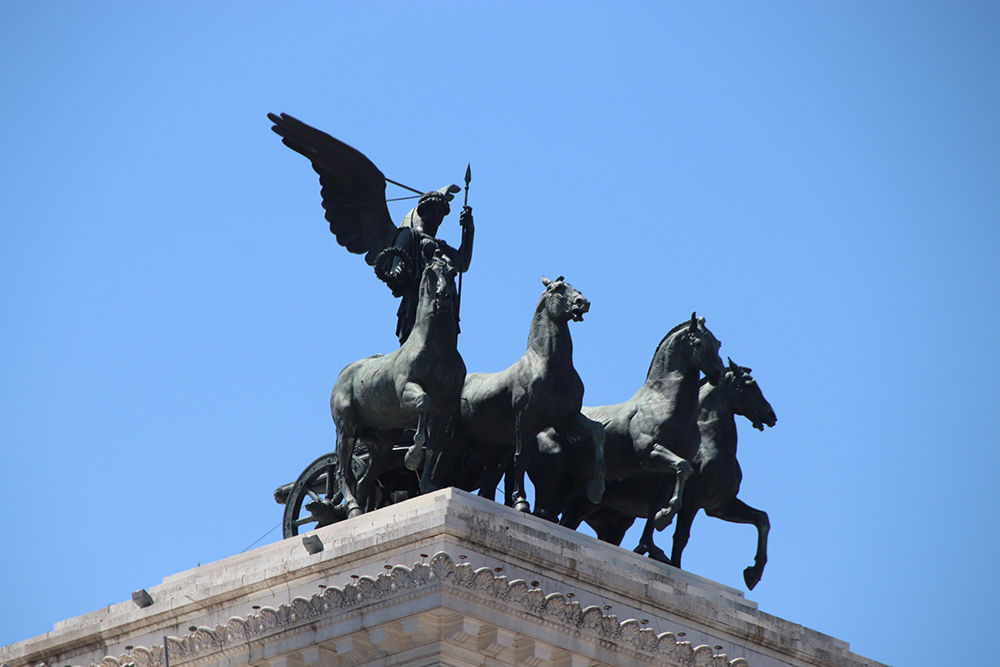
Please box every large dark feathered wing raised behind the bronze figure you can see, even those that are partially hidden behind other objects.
[267,113,397,264]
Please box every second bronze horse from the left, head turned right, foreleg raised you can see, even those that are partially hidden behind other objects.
[461,276,604,512]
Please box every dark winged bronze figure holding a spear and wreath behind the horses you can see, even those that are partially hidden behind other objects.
[267,113,475,345]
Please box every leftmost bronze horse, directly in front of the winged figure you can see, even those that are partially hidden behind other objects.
[330,251,465,517]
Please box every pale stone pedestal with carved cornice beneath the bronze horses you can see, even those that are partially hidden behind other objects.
[0,489,878,667]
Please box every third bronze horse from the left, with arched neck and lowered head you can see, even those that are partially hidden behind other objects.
[552,313,725,562]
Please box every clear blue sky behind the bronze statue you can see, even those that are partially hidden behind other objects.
[0,0,1000,665]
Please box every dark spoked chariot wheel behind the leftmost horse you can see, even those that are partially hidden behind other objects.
[279,453,360,537]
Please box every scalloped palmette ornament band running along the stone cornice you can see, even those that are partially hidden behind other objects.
[82,552,747,667]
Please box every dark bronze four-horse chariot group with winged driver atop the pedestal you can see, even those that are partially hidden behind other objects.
[268,114,776,588]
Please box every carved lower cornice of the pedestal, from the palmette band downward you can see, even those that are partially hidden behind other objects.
[95,552,747,667]
